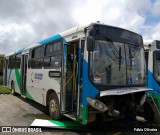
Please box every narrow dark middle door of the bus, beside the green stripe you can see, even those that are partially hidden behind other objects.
[21,54,28,95]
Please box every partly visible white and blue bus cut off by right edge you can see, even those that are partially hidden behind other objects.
[144,40,160,124]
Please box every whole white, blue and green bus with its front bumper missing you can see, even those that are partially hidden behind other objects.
[4,23,155,125]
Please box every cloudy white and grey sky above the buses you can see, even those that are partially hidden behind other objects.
[0,0,160,54]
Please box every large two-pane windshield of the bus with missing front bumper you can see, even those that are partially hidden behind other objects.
[89,40,146,86]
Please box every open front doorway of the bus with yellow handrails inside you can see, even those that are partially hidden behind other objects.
[61,41,79,116]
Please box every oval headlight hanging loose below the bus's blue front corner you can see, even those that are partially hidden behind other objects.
[87,97,108,112]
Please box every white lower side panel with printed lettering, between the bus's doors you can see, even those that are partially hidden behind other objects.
[27,69,61,106]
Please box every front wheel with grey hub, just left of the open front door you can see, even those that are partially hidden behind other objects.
[48,93,61,120]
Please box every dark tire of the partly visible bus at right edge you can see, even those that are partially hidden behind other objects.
[143,99,160,125]
